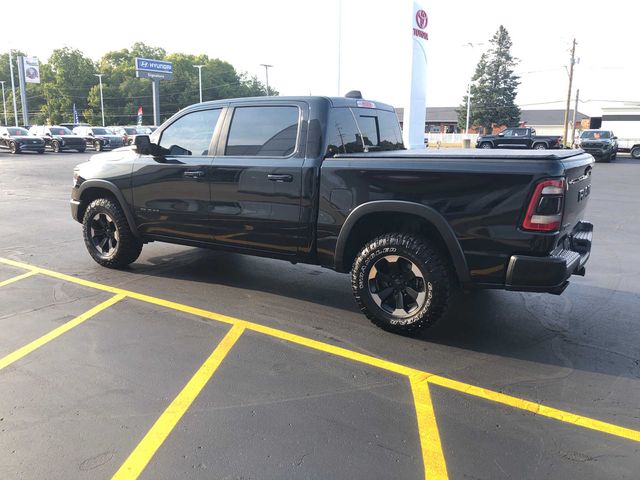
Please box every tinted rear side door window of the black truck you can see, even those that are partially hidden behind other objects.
[225,106,300,157]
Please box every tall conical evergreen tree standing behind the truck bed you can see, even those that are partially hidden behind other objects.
[458,25,520,132]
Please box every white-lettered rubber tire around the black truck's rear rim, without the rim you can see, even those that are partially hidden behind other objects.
[351,233,454,335]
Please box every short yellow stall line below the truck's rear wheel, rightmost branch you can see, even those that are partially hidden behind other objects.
[409,377,449,480]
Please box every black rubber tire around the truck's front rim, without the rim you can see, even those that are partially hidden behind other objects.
[82,198,142,268]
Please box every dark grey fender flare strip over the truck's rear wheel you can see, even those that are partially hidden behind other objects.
[334,200,471,283]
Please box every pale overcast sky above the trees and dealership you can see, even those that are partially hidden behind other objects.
[0,0,640,116]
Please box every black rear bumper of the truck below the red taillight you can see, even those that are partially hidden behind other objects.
[505,222,593,295]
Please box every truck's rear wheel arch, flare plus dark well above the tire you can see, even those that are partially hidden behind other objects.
[334,200,470,284]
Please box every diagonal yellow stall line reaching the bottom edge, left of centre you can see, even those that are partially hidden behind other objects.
[112,325,244,480]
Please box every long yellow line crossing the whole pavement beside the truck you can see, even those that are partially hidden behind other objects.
[0,257,640,442]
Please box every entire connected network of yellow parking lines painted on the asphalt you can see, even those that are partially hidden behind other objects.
[0,258,640,479]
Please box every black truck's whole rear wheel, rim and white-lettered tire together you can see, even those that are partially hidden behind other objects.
[351,233,453,335]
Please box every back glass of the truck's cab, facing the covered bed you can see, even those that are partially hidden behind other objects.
[326,108,404,157]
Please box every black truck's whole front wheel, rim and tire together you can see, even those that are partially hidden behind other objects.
[82,198,142,268]
